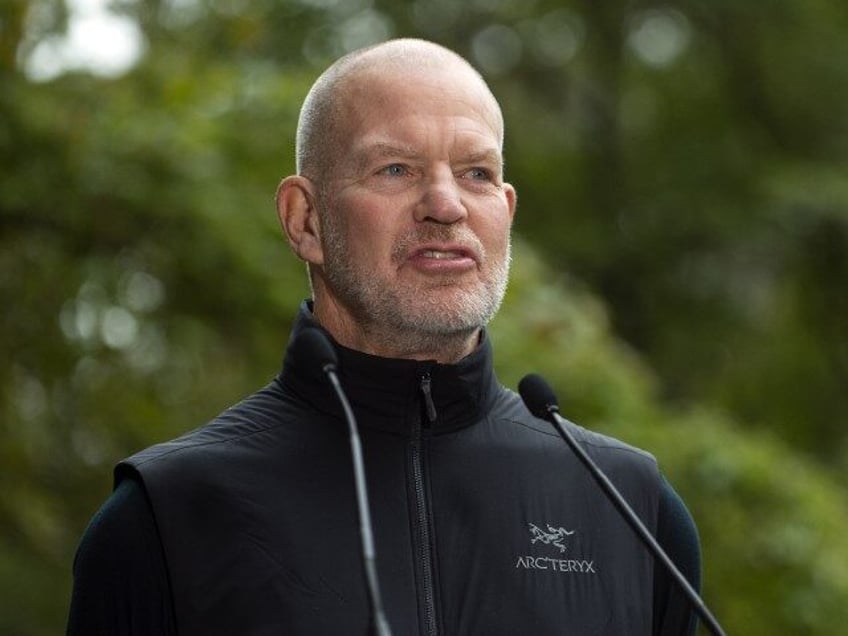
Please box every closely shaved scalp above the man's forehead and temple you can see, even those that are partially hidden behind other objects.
[296,39,503,182]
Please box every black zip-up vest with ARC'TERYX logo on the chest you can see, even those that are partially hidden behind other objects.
[121,306,659,636]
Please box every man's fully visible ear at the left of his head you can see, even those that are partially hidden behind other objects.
[277,175,324,265]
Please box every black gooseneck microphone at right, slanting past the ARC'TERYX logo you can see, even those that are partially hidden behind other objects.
[518,373,725,636]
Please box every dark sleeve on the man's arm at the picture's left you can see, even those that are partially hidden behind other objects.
[67,478,176,636]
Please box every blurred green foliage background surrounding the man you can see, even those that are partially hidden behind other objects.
[0,0,848,636]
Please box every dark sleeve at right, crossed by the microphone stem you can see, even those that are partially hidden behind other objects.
[654,477,701,636]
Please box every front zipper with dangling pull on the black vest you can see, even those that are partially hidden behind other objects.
[411,373,439,636]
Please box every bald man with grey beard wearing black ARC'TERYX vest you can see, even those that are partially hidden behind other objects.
[68,40,700,636]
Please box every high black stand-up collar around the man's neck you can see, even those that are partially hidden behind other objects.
[279,301,497,434]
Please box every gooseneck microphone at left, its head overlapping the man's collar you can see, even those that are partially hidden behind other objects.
[292,328,392,636]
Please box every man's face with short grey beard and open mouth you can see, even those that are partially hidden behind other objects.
[316,70,515,356]
